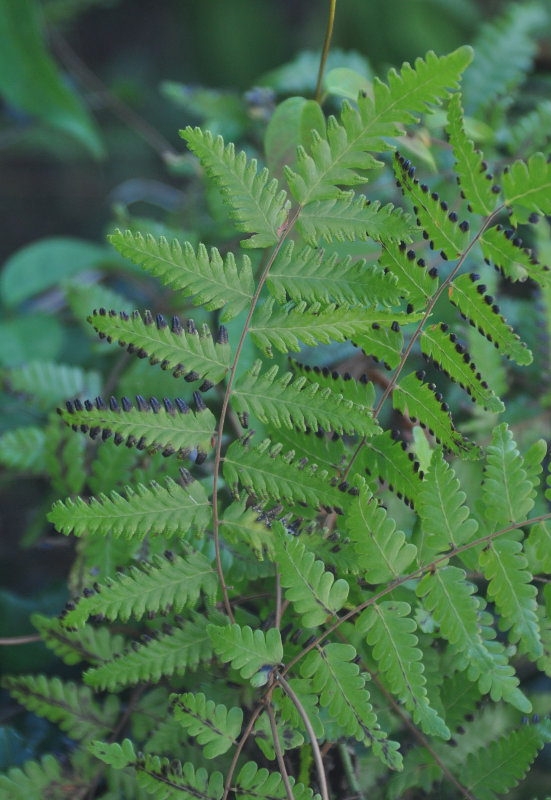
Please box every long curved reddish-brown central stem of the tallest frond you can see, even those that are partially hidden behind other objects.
[212,206,302,624]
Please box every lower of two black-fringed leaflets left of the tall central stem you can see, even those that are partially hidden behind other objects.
[58,392,216,464]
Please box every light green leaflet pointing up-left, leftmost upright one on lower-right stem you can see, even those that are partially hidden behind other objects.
[272,522,349,628]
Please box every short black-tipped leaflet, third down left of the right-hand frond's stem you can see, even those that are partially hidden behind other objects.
[379,240,437,311]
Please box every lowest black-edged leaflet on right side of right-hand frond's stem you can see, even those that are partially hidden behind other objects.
[361,431,423,508]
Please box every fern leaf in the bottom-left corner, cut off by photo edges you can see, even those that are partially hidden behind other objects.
[0,755,67,800]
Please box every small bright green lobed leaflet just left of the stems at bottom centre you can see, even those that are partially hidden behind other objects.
[170,692,243,758]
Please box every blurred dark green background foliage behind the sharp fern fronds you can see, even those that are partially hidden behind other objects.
[0,0,551,780]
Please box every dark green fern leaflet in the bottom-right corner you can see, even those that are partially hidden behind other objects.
[462,719,551,800]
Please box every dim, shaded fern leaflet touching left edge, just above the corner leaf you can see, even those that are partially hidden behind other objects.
[2,675,119,741]
